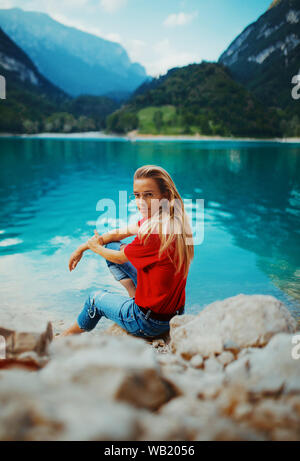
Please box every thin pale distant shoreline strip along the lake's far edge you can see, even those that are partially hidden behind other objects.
[0,131,300,144]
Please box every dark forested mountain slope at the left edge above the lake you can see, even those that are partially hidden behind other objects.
[0,28,119,133]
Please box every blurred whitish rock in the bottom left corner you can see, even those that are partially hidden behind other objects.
[0,371,140,441]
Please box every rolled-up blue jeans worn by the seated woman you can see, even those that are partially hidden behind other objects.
[77,241,184,338]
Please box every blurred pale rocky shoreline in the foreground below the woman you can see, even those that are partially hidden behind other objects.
[0,294,300,441]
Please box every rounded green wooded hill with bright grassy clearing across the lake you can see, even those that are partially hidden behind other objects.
[106,61,280,137]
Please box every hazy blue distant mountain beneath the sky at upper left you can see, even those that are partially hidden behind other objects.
[0,8,148,96]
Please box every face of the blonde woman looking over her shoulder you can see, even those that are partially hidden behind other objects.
[133,178,164,218]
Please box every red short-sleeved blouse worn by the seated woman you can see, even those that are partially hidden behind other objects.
[124,218,187,314]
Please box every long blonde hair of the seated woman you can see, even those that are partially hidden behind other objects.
[133,165,194,277]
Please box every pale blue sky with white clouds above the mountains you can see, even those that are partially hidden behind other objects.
[0,0,272,77]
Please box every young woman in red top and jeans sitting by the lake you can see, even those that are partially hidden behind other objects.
[59,165,194,338]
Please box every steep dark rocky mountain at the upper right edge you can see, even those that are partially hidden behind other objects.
[218,0,300,118]
